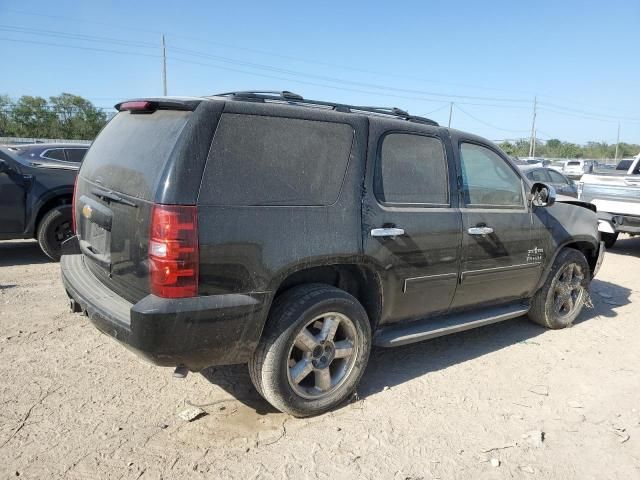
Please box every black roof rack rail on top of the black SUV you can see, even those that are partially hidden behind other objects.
[212,90,439,127]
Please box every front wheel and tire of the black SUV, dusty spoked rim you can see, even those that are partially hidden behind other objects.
[528,248,591,329]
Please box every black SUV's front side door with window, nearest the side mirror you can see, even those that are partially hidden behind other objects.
[452,137,542,308]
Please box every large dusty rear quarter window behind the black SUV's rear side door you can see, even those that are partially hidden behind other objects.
[199,113,353,206]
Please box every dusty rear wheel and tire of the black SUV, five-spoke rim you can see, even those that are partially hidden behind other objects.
[249,284,371,417]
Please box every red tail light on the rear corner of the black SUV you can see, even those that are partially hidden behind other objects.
[149,205,199,298]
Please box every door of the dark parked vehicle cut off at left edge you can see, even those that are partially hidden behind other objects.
[0,155,26,236]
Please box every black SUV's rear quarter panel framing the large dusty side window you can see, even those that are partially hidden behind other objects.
[198,102,368,295]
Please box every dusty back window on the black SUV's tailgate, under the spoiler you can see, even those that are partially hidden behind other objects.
[81,110,191,200]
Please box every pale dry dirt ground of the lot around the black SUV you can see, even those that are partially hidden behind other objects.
[0,239,640,480]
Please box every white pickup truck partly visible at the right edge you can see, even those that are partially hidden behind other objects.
[578,154,640,248]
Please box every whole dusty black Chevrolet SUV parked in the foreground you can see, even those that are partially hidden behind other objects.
[62,92,603,416]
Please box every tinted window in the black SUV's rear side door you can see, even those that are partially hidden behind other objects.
[375,133,449,204]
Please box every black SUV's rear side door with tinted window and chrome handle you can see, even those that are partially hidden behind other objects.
[362,124,462,323]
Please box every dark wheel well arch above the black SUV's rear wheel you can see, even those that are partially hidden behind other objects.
[274,264,382,331]
